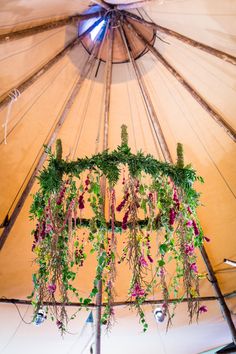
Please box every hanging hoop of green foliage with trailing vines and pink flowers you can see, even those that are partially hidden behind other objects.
[29,126,205,333]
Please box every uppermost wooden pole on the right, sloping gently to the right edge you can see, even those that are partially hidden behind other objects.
[124,11,236,65]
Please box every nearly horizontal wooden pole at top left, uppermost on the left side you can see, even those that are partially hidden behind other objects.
[0,11,104,44]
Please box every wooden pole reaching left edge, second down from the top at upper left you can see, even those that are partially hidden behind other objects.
[0,15,105,109]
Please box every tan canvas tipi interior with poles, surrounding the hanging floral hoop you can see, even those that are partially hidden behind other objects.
[0,0,236,354]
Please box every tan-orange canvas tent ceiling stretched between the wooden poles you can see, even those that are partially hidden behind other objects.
[0,0,236,354]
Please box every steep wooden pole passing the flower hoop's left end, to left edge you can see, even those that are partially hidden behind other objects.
[0,38,101,250]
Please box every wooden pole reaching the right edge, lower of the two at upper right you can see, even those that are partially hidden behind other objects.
[125,21,236,142]
